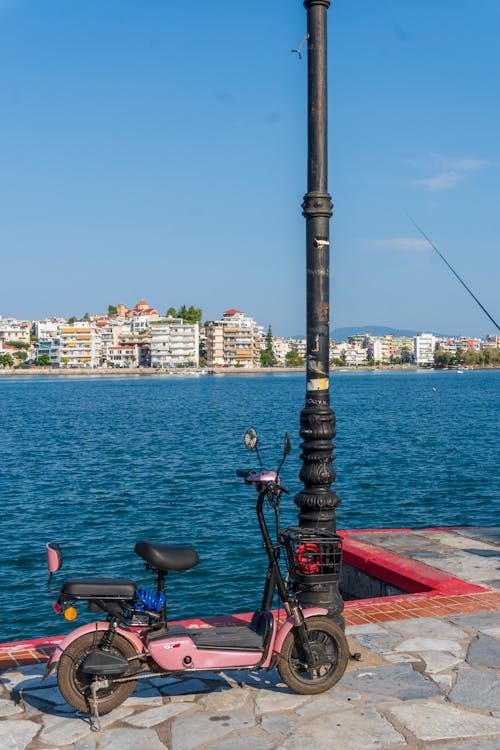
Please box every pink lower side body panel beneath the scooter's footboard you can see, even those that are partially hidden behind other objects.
[148,636,262,672]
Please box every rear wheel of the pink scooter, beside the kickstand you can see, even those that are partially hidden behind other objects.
[57,630,140,714]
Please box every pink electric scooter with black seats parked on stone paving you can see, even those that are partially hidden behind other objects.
[45,429,349,727]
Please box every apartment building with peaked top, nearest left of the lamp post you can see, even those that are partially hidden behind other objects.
[206,308,264,367]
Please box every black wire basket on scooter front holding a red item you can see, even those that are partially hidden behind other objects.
[280,527,342,583]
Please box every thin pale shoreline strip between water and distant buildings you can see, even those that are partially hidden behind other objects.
[0,365,500,378]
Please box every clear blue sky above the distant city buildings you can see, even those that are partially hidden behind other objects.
[0,0,500,335]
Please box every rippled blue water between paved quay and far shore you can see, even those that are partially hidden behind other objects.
[0,371,500,641]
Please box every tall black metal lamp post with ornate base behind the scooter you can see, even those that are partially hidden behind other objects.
[295,0,344,625]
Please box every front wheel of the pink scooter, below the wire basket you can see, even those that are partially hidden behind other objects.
[278,616,349,695]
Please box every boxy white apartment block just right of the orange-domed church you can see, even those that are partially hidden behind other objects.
[150,318,200,367]
